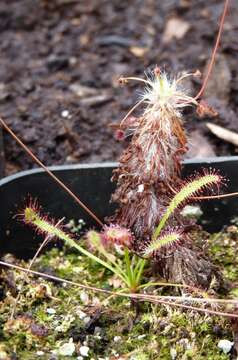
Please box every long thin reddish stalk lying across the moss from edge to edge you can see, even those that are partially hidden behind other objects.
[0,261,238,318]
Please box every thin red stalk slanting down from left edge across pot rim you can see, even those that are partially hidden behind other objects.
[0,118,103,226]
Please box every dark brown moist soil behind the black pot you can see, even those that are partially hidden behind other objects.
[0,0,238,174]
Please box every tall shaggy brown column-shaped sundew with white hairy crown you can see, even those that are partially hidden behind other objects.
[109,68,222,287]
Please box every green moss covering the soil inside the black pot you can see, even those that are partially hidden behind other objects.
[0,228,238,360]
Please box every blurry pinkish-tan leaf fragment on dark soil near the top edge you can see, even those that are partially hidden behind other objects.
[162,17,191,43]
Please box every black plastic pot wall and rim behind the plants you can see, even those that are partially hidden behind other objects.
[0,157,238,258]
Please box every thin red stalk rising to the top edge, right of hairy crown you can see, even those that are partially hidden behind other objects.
[195,0,229,100]
